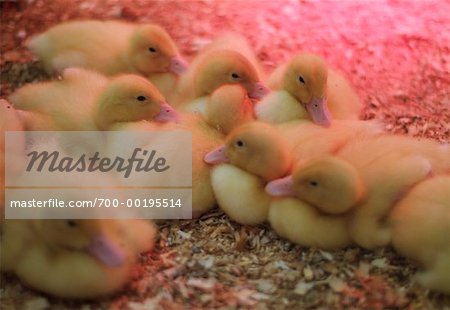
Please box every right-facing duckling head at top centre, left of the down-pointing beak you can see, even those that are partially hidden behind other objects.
[170,42,268,109]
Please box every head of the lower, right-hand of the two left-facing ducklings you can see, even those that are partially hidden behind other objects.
[266,157,365,214]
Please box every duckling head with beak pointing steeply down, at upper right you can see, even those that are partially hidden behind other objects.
[282,54,331,126]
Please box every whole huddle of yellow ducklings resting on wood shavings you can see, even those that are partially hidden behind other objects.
[0,21,450,297]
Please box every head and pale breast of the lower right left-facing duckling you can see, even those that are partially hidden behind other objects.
[266,156,356,249]
